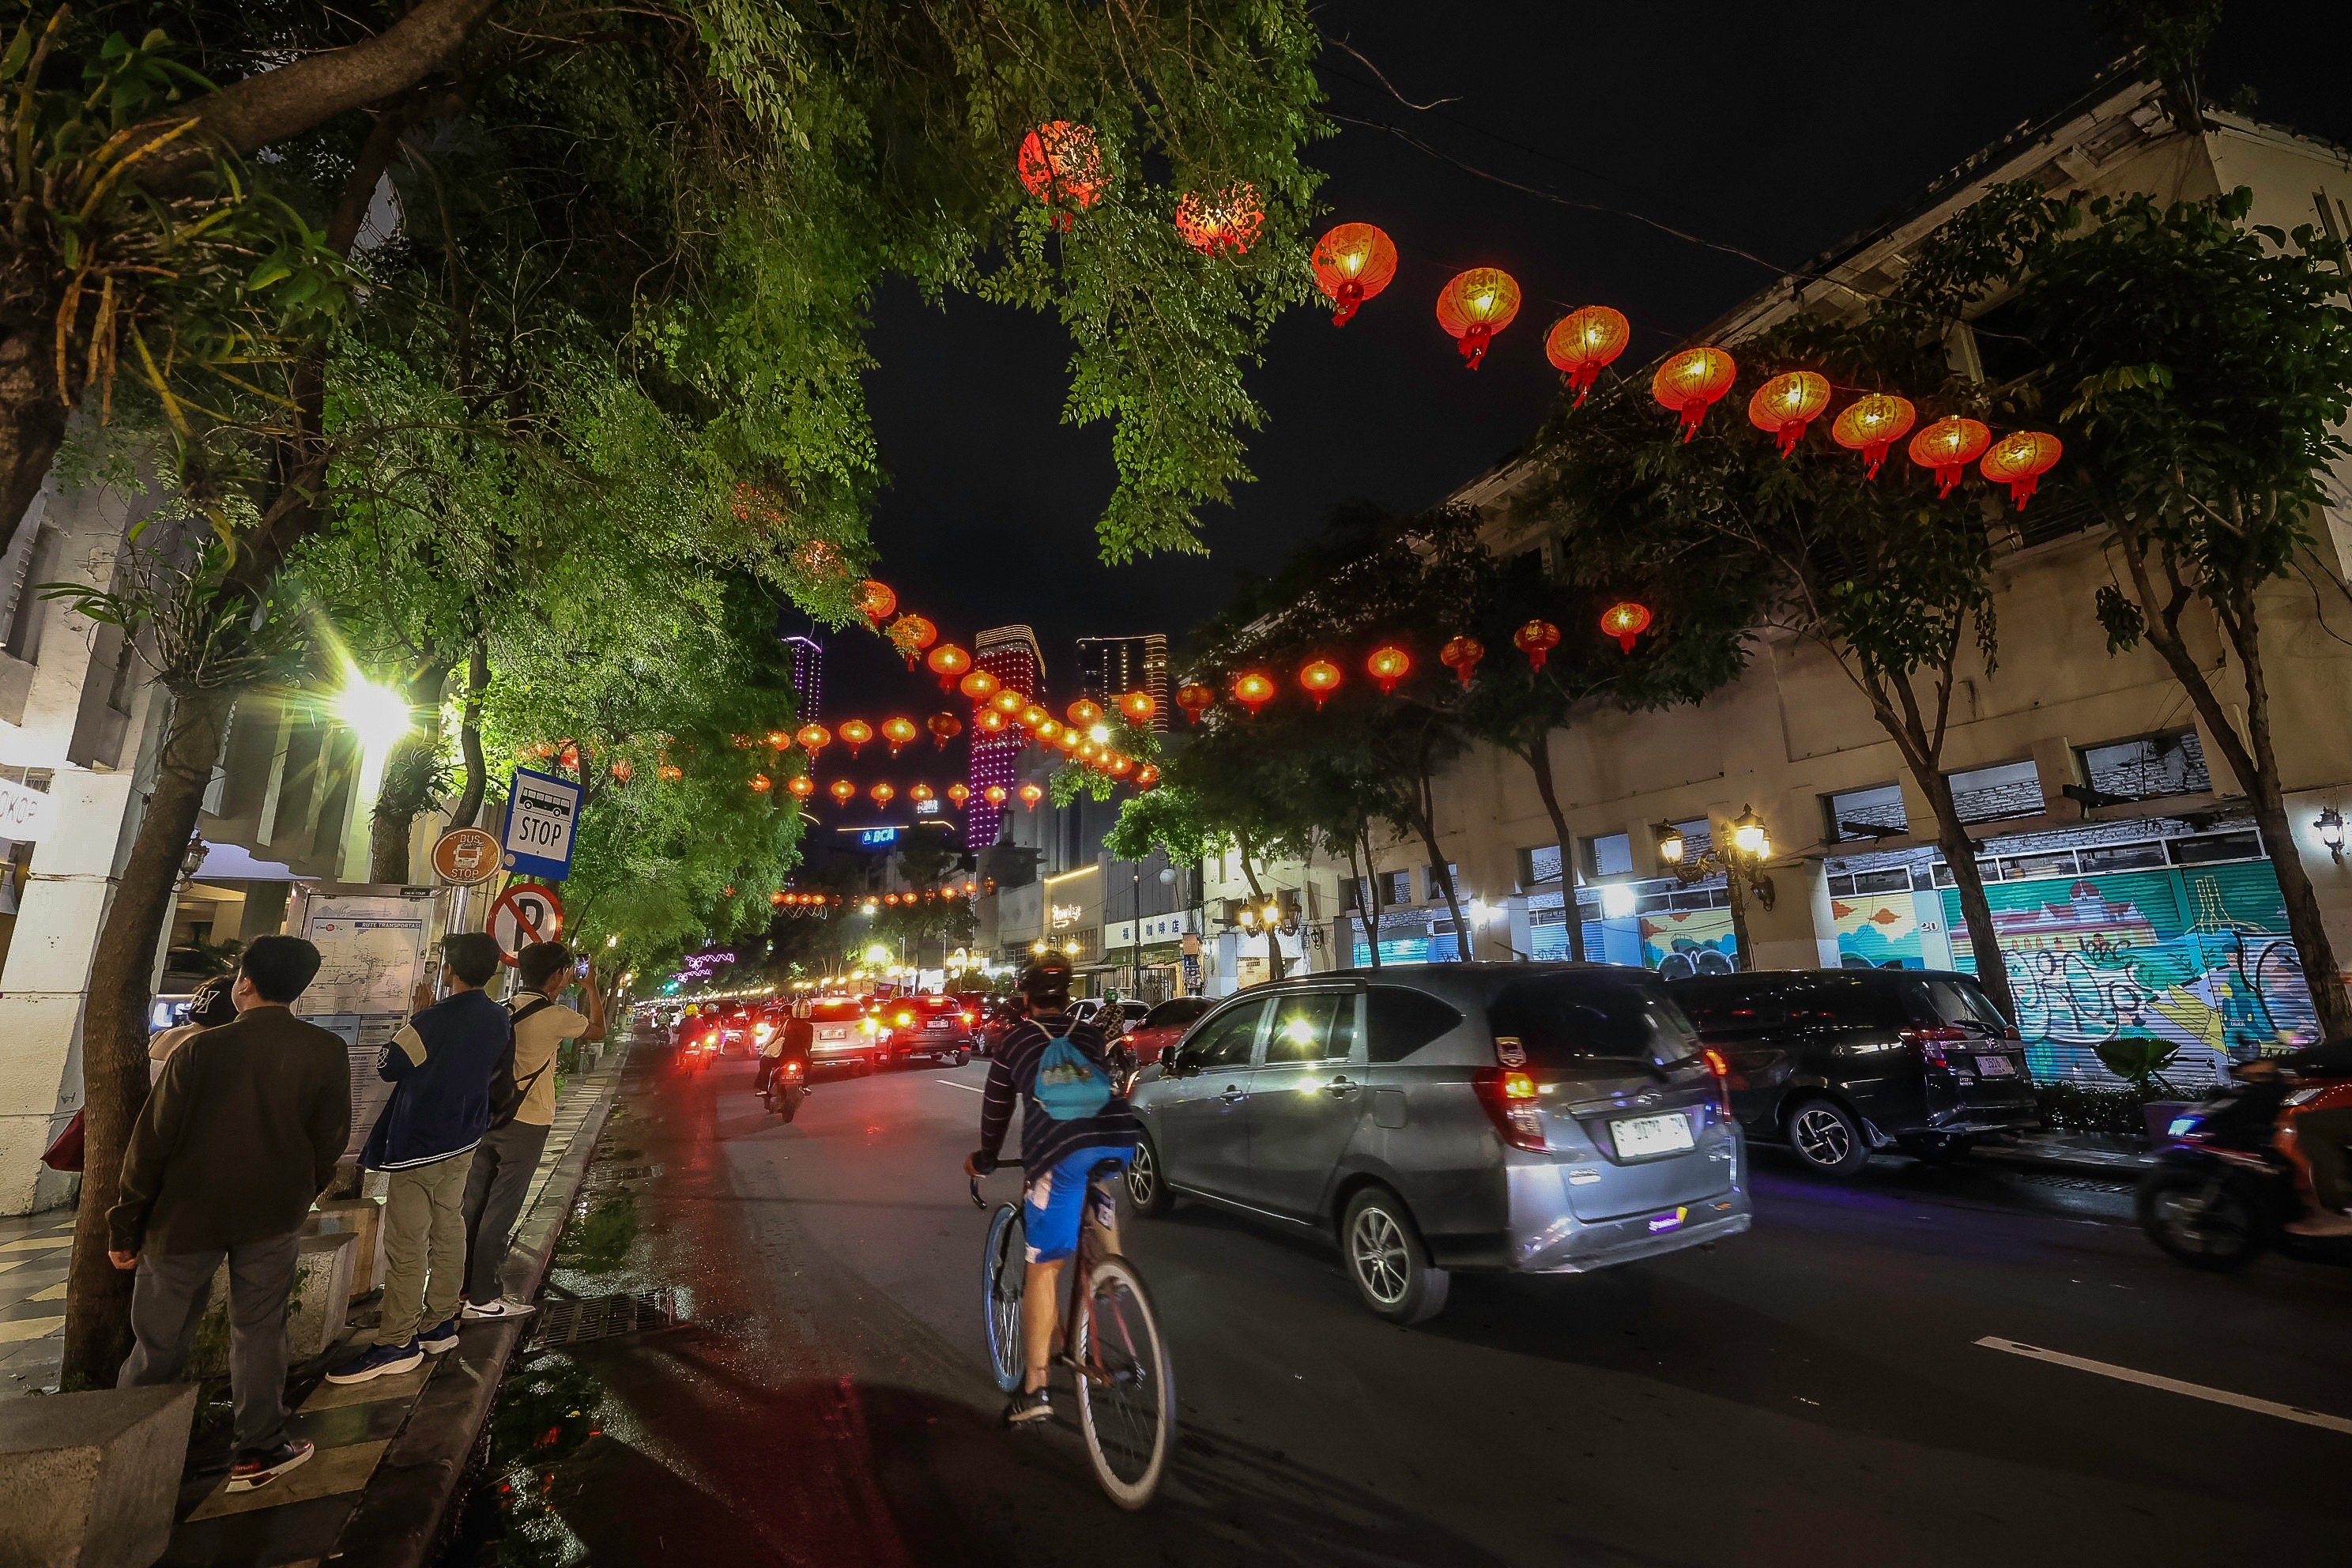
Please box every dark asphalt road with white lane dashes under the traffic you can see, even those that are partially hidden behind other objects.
[529,1051,2352,1568]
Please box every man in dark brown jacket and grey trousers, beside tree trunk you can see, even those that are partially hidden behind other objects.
[106,936,350,1493]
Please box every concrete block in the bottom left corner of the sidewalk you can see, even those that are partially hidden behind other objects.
[0,1382,195,1568]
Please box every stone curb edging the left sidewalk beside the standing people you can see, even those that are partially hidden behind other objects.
[334,1046,631,1568]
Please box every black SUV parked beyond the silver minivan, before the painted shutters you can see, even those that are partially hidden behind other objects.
[1668,968,2041,1175]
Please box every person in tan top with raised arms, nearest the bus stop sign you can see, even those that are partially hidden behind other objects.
[466,943,605,1319]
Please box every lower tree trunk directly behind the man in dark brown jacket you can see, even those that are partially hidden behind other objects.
[61,692,236,1389]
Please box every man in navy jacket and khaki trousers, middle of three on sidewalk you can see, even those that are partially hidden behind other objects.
[327,931,515,1382]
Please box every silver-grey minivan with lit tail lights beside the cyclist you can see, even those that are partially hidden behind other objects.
[1127,964,1750,1324]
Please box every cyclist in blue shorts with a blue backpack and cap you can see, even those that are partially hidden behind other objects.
[964,955,1136,1425]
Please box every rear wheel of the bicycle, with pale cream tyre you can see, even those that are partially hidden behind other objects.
[1070,1257,1176,1510]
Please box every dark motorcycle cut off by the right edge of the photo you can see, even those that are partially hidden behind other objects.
[2138,1076,2352,1274]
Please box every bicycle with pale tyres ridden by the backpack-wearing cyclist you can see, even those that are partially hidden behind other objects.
[971,1159,1176,1510]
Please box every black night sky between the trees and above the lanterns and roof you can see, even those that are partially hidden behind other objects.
[790,0,2352,823]
